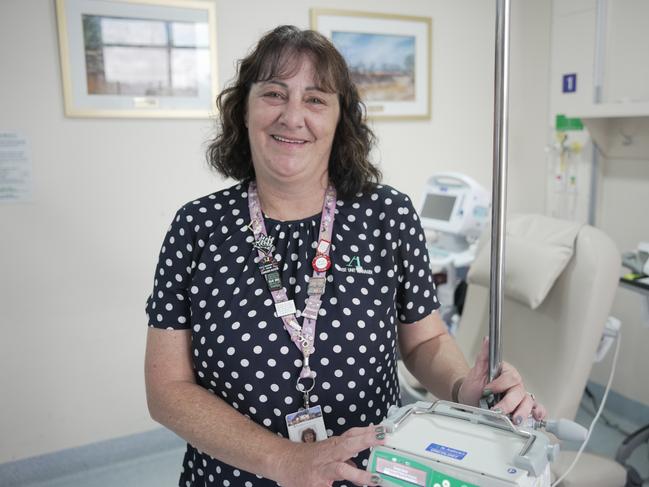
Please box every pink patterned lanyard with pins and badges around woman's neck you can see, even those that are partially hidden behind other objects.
[248,181,336,398]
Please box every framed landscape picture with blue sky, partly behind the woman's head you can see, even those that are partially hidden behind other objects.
[311,9,432,119]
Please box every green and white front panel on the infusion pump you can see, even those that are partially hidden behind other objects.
[371,450,479,487]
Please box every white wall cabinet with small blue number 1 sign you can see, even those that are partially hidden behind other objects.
[551,0,649,158]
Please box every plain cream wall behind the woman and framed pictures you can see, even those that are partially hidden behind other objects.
[0,0,550,463]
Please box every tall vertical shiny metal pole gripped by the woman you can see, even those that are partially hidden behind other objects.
[489,0,510,382]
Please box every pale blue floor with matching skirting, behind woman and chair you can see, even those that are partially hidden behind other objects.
[0,392,649,487]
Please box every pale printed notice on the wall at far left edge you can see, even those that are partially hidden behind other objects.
[0,131,32,203]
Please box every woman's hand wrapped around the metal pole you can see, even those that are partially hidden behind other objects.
[458,338,546,425]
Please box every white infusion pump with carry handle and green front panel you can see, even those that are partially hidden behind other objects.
[367,401,559,487]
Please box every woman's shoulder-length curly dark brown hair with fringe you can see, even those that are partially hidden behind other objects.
[207,25,381,199]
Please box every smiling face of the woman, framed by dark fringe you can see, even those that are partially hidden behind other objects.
[246,56,340,187]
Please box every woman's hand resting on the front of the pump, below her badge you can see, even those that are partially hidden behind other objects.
[274,426,385,487]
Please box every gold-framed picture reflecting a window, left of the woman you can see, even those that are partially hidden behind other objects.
[56,0,217,118]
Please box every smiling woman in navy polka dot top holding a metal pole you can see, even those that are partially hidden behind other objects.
[146,26,532,487]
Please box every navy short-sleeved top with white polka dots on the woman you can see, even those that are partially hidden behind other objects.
[147,183,439,487]
